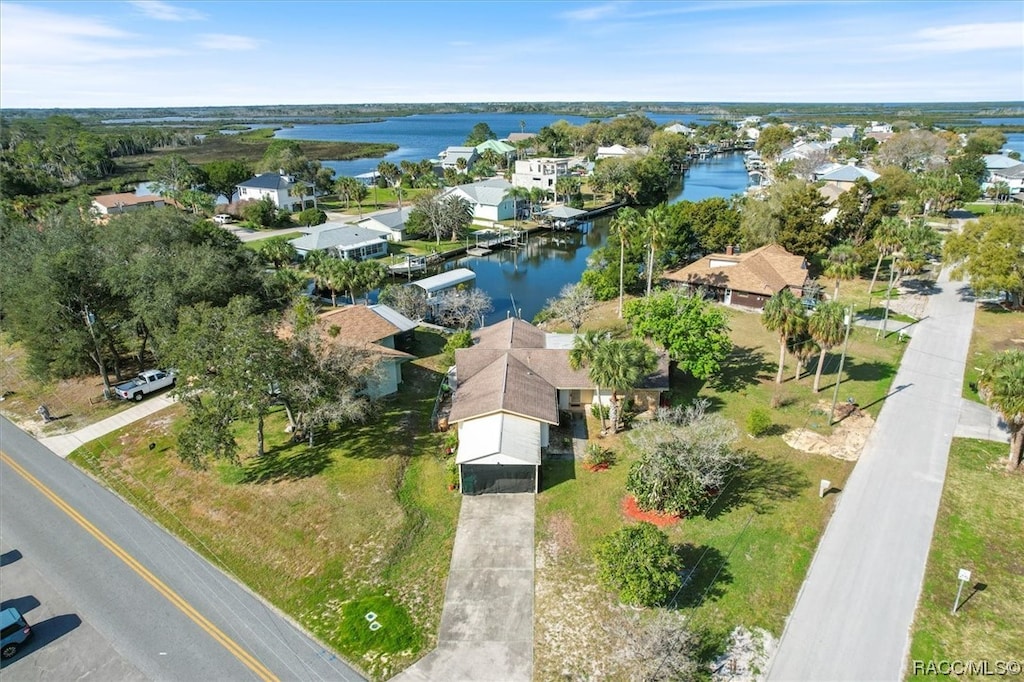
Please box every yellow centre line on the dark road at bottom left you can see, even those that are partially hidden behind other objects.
[0,451,278,682]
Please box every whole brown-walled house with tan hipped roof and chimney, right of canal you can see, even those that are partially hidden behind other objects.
[665,244,810,310]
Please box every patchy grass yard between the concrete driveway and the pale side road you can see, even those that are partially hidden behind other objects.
[535,301,903,679]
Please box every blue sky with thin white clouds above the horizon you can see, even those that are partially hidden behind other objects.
[0,0,1024,109]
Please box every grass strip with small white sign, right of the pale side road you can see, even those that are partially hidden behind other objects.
[907,438,1024,680]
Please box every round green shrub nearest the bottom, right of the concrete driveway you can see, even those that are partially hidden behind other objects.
[594,522,682,606]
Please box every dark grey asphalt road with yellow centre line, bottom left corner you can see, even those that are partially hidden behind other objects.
[0,418,364,680]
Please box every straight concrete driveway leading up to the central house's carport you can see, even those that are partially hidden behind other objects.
[393,494,535,682]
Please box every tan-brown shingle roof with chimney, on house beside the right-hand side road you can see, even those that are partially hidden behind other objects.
[665,244,807,296]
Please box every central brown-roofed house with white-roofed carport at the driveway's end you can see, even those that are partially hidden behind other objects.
[447,317,669,495]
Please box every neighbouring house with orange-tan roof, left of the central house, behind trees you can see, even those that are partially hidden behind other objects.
[296,305,416,398]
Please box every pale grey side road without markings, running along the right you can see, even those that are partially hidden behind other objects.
[768,273,974,681]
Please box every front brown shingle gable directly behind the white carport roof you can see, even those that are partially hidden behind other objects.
[449,348,558,424]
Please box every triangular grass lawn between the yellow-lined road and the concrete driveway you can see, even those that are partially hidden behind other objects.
[71,331,460,679]
